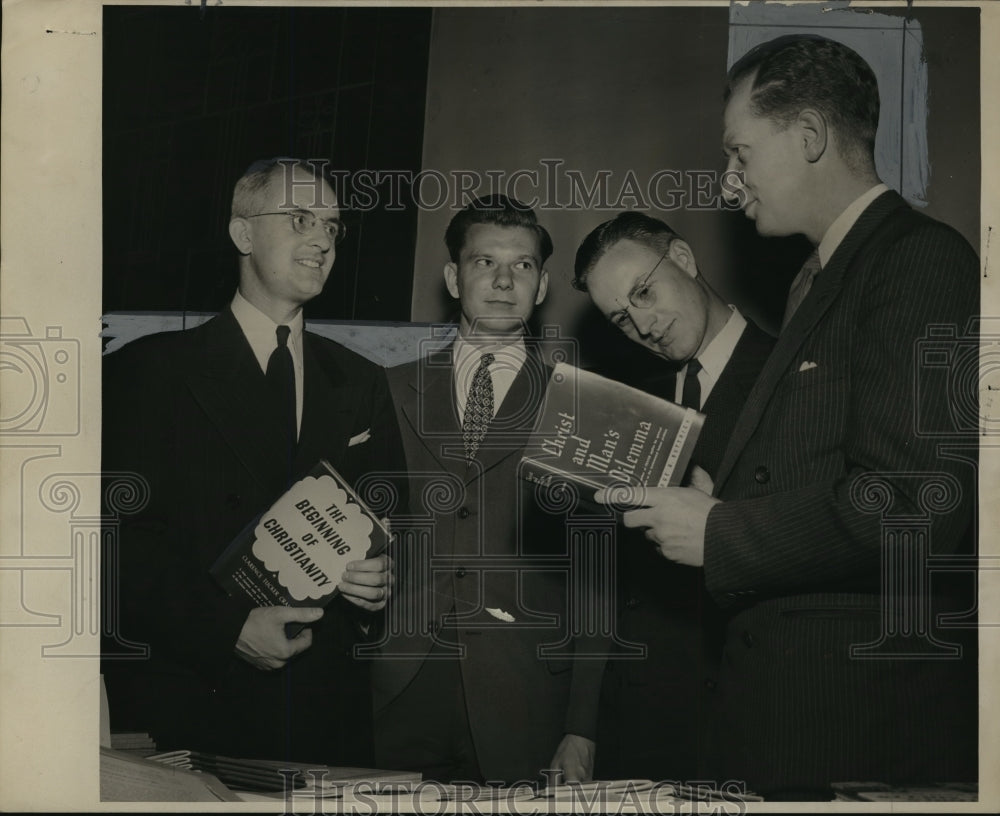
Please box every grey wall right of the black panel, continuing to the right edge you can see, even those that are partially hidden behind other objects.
[413,4,980,379]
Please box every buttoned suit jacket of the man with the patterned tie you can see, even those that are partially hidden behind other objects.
[373,348,603,781]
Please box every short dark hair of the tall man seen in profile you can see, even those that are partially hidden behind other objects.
[725,34,879,166]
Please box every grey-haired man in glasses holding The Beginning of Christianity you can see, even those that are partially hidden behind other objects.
[103,160,402,765]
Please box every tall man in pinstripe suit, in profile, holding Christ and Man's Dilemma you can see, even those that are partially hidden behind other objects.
[596,36,979,799]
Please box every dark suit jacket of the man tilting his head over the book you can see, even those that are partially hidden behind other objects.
[597,321,774,780]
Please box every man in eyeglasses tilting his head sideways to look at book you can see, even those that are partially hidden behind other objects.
[573,212,774,780]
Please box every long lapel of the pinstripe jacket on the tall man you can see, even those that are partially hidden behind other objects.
[715,191,907,494]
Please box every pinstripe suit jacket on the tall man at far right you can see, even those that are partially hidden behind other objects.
[705,192,979,793]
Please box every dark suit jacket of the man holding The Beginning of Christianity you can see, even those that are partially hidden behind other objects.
[102,309,400,765]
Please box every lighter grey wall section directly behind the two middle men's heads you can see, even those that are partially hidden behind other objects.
[413,7,752,379]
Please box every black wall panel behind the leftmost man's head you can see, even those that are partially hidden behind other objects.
[103,3,431,320]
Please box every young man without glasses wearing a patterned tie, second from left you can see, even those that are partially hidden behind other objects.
[373,196,603,783]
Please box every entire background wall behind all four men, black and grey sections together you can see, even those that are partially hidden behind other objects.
[103,4,980,379]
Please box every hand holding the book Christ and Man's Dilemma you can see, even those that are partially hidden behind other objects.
[595,487,720,567]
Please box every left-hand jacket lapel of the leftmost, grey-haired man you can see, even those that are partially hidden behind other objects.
[187,309,288,491]
